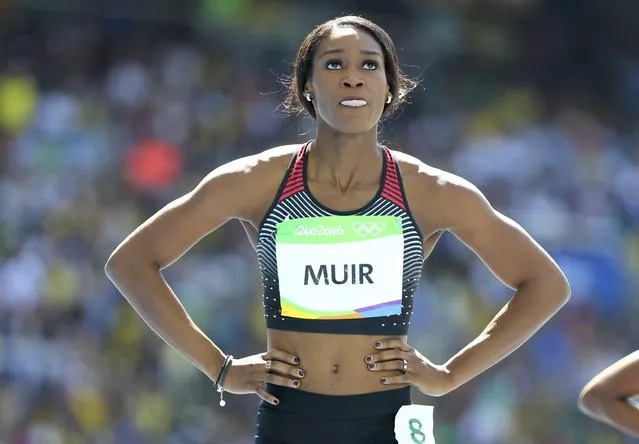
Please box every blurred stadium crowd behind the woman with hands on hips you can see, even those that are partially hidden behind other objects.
[0,0,639,444]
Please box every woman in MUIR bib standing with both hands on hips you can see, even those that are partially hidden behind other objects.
[106,16,570,444]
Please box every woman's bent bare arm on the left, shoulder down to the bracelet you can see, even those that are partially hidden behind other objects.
[105,156,276,380]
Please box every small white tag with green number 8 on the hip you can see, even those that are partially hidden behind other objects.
[395,405,435,444]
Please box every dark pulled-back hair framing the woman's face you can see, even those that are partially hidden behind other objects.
[284,15,417,119]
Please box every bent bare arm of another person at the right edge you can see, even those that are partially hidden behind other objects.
[579,351,639,438]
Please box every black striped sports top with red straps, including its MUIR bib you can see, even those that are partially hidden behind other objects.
[256,142,424,335]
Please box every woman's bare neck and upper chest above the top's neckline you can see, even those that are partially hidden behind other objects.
[309,122,381,188]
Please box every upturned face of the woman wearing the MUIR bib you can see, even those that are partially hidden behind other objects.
[306,28,389,134]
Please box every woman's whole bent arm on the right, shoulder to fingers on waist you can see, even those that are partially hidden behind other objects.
[366,162,570,396]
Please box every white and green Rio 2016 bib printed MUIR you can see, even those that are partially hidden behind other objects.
[275,216,404,319]
